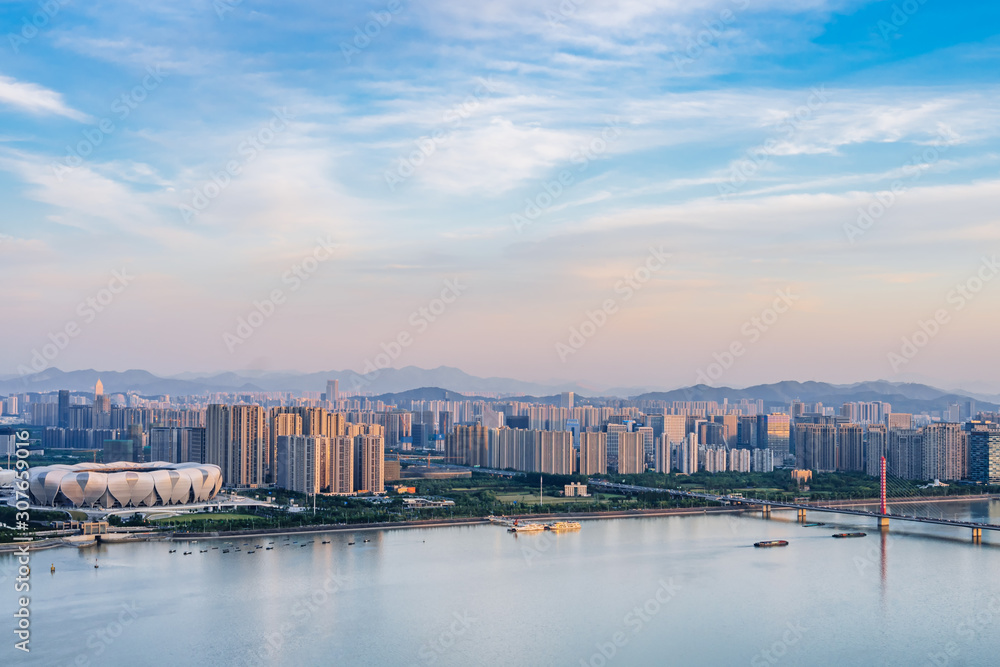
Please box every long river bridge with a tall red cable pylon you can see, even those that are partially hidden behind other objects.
[587,457,1000,543]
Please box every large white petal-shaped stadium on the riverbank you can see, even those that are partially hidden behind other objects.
[28,461,222,509]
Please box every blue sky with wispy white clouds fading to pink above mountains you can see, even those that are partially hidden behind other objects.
[0,0,1000,391]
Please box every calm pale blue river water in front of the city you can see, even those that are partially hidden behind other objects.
[0,502,1000,667]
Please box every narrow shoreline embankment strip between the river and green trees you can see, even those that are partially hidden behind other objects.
[0,494,1000,556]
